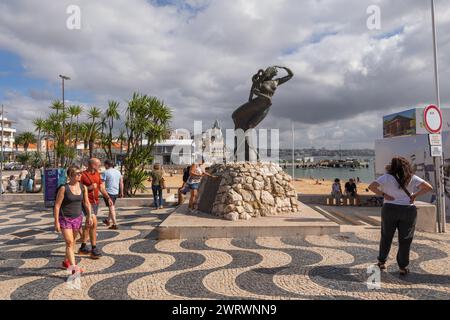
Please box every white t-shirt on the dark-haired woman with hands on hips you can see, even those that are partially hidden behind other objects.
[376,174,425,206]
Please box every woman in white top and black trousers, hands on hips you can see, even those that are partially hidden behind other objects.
[369,157,433,276]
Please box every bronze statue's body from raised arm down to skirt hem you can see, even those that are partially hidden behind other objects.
[233,66,294,131]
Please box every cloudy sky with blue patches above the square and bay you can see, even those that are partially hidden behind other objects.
[0,0,450,148]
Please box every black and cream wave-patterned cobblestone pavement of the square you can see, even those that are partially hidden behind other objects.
[0,203,450,300]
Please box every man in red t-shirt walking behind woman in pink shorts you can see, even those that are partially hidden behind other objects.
[78,158,112,259]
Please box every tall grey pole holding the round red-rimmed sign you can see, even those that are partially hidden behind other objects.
[431,0,447,233]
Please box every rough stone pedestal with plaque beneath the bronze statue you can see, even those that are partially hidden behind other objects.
[199,162,300,221]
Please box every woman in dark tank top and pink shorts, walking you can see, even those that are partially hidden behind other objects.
[54,166,92,272]
